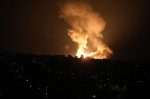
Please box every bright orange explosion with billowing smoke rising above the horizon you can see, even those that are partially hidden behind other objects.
[60,2,113,59]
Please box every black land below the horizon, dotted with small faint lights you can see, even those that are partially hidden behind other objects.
[0,53,150,99]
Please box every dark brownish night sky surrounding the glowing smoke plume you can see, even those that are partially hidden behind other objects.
[0,0,150,60]
